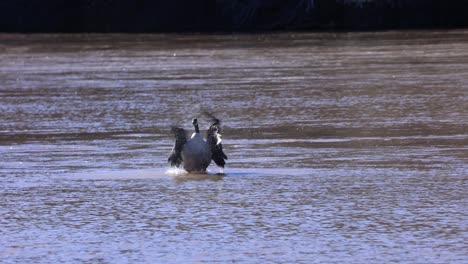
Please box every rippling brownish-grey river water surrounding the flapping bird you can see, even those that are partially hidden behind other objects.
[0,31,468,263]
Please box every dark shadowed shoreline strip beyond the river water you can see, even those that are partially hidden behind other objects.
[0,0,468,33]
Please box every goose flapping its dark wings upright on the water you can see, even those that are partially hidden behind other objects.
[167,115,227,173]
